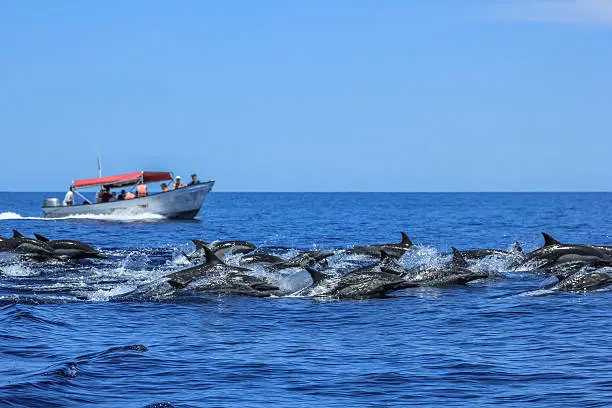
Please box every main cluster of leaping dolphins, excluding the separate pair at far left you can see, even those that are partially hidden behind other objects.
[113,233,612,299]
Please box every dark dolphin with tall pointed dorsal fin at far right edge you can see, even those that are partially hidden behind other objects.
[523,232,612,271]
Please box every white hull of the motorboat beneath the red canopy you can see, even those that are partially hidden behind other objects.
[43,180,215,219]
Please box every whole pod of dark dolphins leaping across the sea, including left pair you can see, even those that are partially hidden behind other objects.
[0,230,612,300]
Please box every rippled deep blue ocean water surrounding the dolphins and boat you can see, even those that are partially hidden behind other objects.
[0,192,612,407]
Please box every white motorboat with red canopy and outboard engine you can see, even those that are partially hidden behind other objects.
[43,171,215,219]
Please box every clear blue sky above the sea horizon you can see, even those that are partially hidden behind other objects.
[0,0,612,191]
